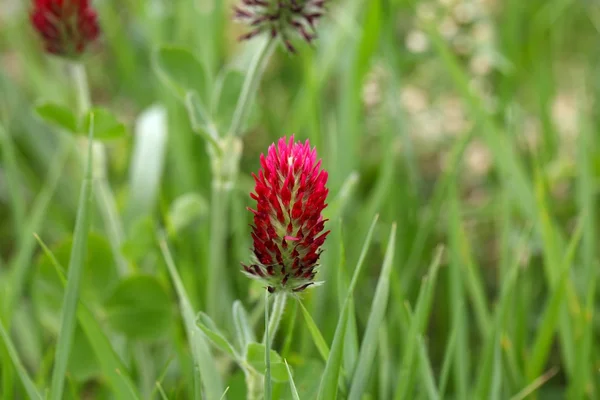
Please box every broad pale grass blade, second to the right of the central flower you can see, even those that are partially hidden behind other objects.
[348,224,396,400]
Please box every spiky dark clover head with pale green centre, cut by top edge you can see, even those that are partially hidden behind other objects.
[234,0,327,53]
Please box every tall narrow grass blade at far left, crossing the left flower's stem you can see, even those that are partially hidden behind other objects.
[50,114,94,400]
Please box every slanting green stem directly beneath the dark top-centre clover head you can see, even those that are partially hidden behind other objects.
[227,38,277,135]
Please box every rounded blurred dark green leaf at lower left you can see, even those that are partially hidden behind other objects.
[105,275,173,340]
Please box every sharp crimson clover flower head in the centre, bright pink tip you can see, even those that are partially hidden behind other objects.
[242,135,329,293]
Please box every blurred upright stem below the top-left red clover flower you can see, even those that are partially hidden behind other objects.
[69,62,129,275]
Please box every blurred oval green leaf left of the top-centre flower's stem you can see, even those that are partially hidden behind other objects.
[154,45,207,99]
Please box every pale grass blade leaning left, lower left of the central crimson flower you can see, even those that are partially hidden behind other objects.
[159,235,223,399]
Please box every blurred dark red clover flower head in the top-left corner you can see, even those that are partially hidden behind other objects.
[30,0,100,57]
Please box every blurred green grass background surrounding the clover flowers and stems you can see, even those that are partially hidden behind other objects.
[0,0,600,399]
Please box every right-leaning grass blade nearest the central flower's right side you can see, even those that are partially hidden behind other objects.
[317,215,378,400]
